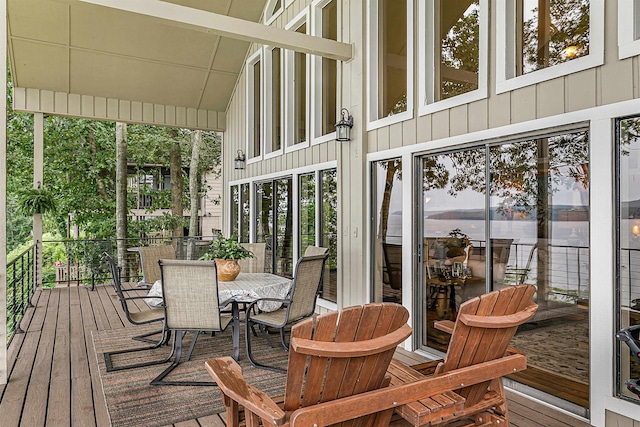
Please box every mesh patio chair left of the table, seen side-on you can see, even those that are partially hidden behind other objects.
[103,252,169,372]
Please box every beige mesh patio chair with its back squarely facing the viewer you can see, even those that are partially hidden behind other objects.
[151,259,240,386]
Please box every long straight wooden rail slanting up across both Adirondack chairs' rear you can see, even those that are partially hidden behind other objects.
[290,354,527,427]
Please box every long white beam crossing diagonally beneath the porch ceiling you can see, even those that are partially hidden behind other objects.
[78,0,353,61]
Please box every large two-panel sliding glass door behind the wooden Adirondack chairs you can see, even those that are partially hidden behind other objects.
[415,131,590,416]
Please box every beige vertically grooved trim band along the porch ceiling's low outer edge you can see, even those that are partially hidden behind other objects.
[13,87,226,132]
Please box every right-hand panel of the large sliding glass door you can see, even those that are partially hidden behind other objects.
[489,132,590,415]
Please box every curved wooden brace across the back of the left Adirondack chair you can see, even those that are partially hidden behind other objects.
[291,324,411,357]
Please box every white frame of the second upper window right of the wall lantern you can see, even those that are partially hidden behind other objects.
[418,0,489,116]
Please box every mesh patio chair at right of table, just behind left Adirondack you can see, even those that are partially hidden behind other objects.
[245,253,329,372]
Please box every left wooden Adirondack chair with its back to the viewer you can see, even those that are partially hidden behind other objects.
[206,303,411,427]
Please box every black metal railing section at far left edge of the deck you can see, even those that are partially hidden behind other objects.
[7,245,37,345]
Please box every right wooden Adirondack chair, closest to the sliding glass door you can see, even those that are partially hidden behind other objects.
[389,285,538,427]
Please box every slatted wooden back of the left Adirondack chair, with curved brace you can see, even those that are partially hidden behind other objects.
[284,303,411,425]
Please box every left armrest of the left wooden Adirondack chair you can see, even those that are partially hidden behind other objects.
[205,357,285,425]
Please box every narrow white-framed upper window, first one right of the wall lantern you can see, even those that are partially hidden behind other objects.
[369,0,413,128]
